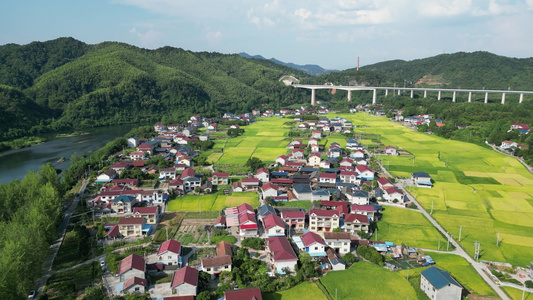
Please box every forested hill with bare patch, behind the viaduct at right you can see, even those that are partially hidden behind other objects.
[361,51,533,90]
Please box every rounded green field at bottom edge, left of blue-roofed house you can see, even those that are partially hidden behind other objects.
[320,261,417,300]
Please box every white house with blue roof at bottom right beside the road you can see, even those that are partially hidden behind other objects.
[420,267,463,300]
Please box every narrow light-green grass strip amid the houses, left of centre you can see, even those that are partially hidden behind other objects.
[167,192,259,212]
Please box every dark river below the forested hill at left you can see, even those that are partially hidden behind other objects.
[0,124,140,183]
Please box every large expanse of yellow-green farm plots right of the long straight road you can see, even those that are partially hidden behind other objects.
[336,114,533,266]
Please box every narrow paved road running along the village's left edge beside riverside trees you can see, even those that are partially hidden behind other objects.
[36,180,88,295]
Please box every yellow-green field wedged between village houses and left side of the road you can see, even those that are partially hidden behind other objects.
[377,206,445,250]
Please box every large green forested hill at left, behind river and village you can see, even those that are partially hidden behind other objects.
[0,38,306,140]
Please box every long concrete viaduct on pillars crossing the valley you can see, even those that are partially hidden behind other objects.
[292,84,533,106]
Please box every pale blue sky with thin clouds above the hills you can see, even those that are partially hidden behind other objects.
[0,0,533,70]
